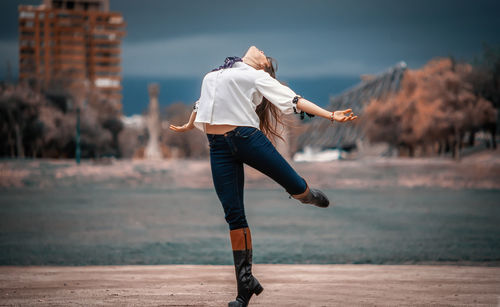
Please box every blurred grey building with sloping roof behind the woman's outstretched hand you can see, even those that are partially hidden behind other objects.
[297,62,406,158]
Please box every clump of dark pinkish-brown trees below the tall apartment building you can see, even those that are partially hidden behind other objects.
[0,78,123,158]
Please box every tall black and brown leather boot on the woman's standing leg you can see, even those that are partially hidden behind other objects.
[228,227,264,307]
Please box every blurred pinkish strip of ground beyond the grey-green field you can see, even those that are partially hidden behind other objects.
[0,149,500,189]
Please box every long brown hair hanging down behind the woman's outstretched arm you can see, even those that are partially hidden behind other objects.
[255,57,285,141]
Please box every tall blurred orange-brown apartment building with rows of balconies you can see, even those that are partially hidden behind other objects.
[19,0,125,107]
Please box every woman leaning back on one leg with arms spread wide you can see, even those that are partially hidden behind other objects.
[170,46,357,306]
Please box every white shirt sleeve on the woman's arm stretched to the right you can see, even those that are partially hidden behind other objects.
[255,71,297,114]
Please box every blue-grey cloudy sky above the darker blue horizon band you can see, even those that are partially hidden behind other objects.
[0,0,500,79]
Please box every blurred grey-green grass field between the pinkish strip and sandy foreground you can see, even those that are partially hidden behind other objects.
[0,184,500,266]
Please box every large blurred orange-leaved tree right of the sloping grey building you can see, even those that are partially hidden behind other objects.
[363,58,497,157]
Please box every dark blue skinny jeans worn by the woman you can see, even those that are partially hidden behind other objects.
[207,126,307,230]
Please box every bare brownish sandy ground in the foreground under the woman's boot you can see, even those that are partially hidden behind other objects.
[0,264,500,306]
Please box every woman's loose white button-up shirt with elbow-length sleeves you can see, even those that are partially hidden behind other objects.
[194,62,297,132]
